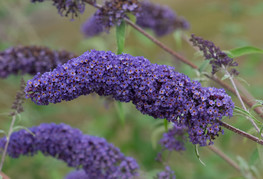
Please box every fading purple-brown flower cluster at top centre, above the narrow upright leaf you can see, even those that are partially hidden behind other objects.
[94,0,140,30]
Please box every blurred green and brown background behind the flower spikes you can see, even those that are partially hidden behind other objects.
[0,0,263,179]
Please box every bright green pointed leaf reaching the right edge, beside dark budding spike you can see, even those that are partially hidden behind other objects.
[225,46,263,58]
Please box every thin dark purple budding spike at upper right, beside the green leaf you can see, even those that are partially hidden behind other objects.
[190,34,239,75]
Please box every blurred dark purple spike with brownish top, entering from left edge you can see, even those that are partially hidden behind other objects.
[0,46,75,78]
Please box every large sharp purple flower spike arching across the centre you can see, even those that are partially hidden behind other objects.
[25,50,234,146]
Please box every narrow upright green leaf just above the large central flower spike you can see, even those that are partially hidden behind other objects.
[116,21,126,54]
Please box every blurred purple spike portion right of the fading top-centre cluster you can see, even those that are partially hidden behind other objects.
[136,1,189,36]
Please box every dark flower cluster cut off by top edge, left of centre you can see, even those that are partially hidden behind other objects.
[31,0,96,18]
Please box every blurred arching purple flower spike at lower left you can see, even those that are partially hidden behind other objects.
[0,123,138,179]
